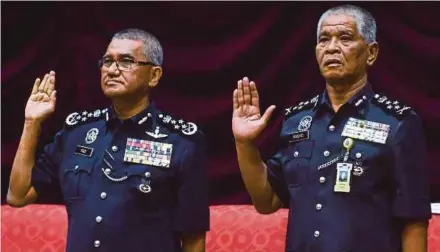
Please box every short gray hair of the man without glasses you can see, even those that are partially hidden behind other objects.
[316,4,377,44]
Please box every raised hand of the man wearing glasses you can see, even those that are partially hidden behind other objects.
[24,71,56,121]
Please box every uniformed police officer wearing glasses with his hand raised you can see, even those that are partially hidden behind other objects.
[7,29,209,252]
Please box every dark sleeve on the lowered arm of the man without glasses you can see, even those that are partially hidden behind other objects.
[392,112,431,219]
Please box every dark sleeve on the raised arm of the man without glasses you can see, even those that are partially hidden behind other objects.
[266,150,290,207]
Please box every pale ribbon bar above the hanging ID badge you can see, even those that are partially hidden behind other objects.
[341,117,390,144]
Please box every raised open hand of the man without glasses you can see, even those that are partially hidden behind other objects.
[232,77,275,142]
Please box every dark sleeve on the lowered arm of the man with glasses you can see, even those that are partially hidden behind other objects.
[174,133,209,233]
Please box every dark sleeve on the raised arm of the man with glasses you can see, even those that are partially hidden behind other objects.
[31,129,65,201]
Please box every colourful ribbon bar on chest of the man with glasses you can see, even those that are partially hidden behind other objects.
[124,138,173,168]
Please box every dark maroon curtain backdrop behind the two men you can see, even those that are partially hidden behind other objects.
[1,2,440,204]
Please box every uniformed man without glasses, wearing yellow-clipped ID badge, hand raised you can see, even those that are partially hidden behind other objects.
[232,5,431,252]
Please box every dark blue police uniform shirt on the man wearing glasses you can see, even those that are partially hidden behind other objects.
[32,103,209,252]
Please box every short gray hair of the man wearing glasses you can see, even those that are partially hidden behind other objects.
[112,28,163,66]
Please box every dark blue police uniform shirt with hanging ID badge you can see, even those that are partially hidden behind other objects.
[267,84,431,252]
